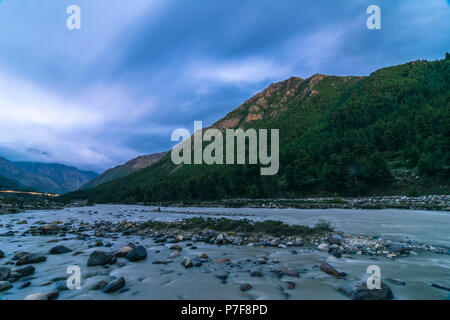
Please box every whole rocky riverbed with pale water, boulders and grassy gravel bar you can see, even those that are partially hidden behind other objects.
[0,205,450,300]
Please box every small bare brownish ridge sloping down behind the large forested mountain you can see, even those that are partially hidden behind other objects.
[80,152,167,190]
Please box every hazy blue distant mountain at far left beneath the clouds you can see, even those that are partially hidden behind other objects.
[0,157,98,194]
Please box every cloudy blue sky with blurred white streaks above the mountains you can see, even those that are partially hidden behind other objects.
[0,0,450,172]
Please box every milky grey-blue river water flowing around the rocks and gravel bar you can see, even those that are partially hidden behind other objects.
[0,205,450,300]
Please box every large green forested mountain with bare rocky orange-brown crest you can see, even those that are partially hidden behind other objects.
[67,58,450,203]
